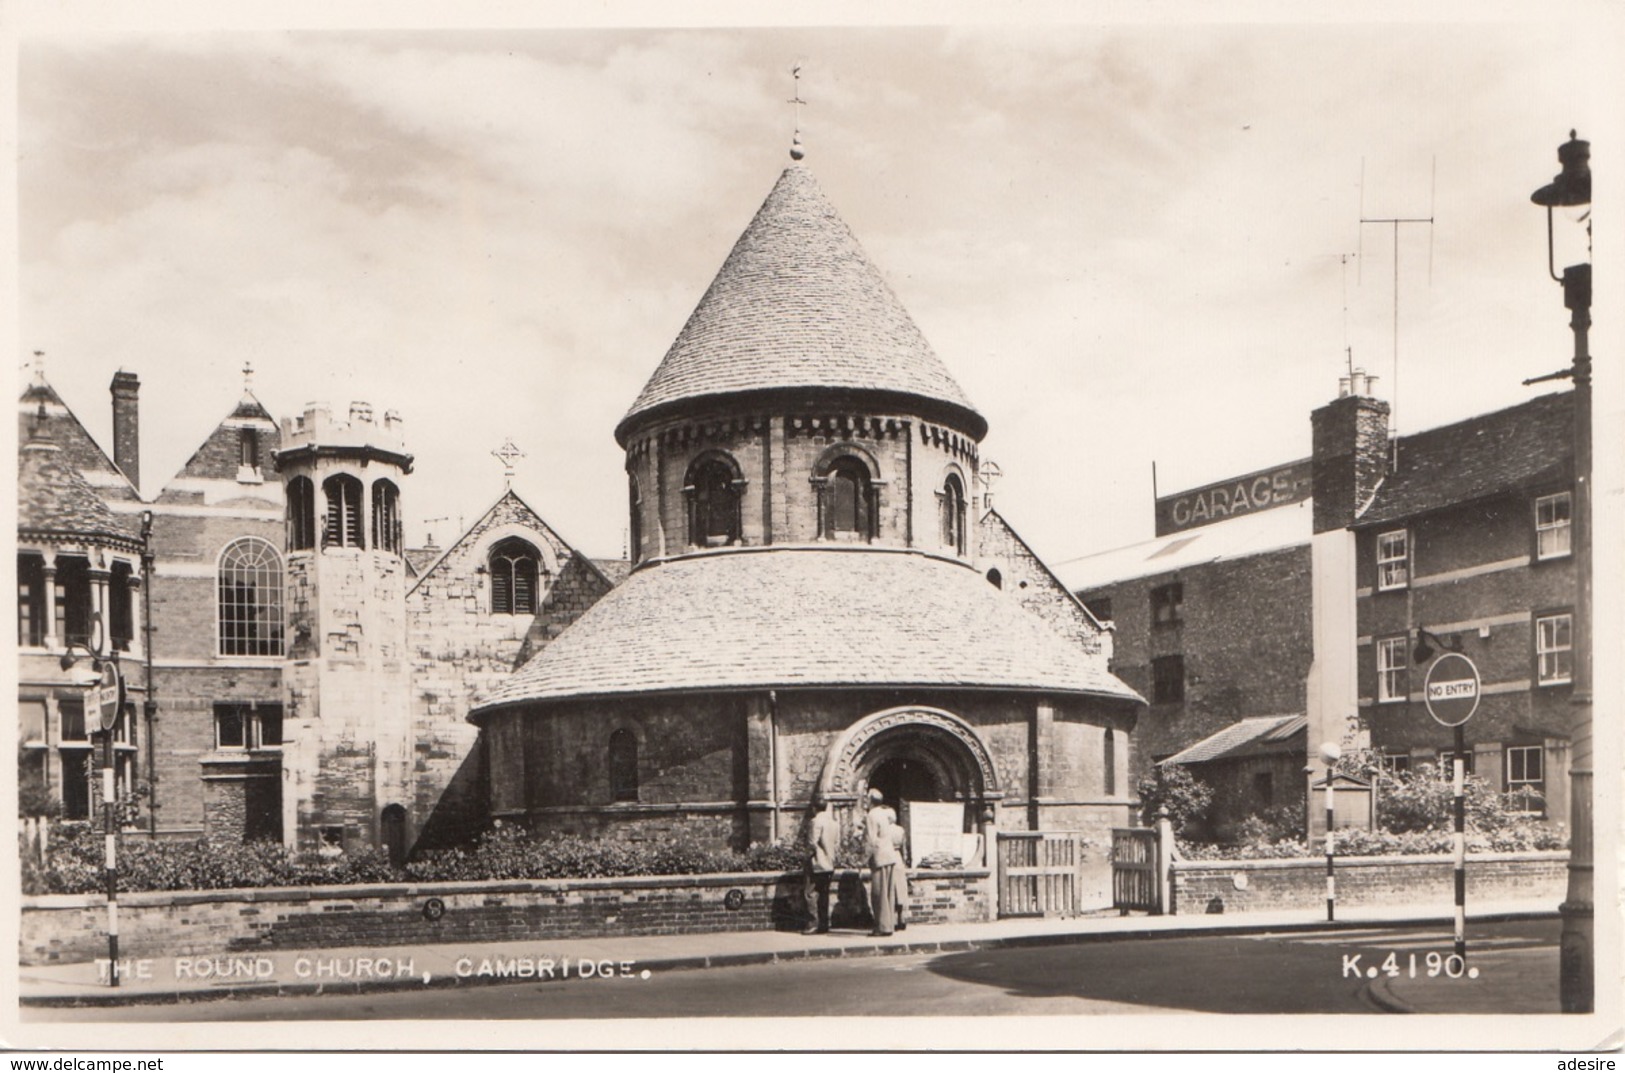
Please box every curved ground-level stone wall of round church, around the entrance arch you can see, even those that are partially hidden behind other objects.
[486,689,1133,847]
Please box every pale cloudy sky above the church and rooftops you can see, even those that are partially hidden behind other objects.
[7,3,1625,563]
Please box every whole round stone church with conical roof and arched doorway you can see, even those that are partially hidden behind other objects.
[470,148,1142,847]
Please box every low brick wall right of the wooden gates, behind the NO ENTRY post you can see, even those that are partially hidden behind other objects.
[1173,850,1568,914]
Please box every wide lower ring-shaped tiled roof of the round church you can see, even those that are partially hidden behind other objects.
[478,548,1139,710]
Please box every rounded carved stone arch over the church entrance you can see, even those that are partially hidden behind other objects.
[819,707,1003,831]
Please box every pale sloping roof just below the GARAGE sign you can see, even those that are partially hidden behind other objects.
[1055,499,1315,592]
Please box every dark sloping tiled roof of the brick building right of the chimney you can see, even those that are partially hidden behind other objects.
[1355,392,1575,527]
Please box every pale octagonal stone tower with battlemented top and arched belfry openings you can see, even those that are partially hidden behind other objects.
[276,402,413,858]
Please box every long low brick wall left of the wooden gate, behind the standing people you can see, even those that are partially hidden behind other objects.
[18,870,995,964]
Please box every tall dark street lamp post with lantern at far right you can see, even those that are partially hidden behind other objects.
[1529,130,1596,1013]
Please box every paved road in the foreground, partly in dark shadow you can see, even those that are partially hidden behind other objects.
[24,920,1560,1023]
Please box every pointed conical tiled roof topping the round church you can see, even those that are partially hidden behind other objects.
[616,164,986,442]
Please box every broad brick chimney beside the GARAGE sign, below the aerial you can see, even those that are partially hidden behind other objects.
[1310,369,1388,533]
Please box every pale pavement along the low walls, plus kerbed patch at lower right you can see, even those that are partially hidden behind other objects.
[18,901,1557,1013]
